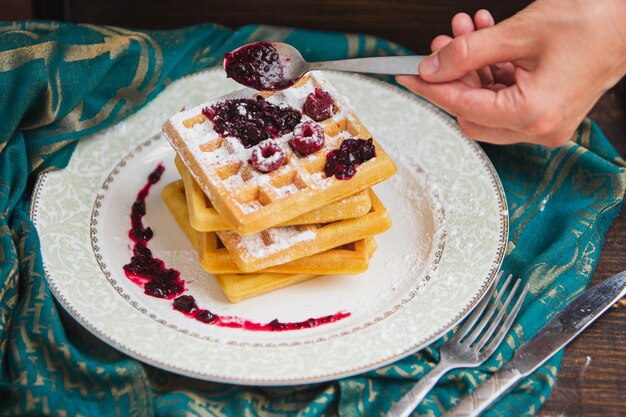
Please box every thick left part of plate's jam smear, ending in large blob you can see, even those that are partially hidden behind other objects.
[124,164,185,299]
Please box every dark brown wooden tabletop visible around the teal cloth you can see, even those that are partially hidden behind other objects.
[0,0,626,417]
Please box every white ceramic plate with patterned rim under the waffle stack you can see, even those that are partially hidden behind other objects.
[31,70,508,385]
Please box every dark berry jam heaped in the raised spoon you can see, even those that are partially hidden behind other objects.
[224,42,295,90]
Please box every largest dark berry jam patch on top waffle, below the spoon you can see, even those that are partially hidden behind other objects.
[202,96,302,148]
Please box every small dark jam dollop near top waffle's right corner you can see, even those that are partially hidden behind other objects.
[324,139,376,180]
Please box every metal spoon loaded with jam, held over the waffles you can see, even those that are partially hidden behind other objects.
[224,42,426,90]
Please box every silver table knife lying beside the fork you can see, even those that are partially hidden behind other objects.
[446,271,626,417]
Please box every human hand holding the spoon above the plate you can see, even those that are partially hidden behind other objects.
[397,0,626,146]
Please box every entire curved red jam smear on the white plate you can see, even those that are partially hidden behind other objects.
[123,164,350,332]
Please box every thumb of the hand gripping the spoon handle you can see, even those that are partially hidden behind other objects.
[419,22,528,82]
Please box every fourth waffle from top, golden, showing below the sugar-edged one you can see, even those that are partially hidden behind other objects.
[162,181,376,275]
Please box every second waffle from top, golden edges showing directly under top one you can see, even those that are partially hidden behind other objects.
[175,156,372,231]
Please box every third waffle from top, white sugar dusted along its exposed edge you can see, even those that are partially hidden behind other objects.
[214,189,391,272]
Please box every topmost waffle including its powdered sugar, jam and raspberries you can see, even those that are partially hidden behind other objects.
[163,73,396,234]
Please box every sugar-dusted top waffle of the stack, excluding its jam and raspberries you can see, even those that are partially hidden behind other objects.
[163,73,396,235]
